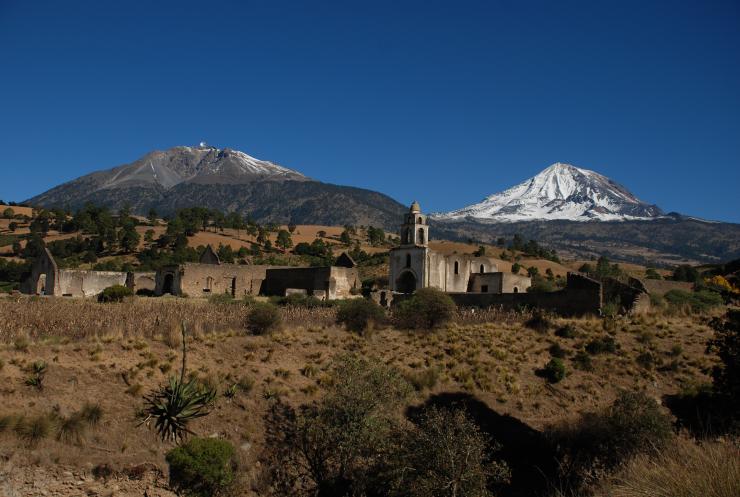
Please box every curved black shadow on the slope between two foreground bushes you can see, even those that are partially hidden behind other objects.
[406,392,557,497]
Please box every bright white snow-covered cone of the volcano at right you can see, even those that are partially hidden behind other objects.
[433,162,663,222]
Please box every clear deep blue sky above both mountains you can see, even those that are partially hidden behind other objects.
[0,0,740,222]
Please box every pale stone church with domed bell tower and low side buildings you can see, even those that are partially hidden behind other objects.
[388,202,531,293]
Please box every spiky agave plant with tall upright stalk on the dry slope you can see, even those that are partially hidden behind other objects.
[140,323,217,443]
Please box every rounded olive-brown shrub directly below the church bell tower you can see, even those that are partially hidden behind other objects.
[393,288,457,329]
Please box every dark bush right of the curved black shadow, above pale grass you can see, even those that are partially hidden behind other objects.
[546,392,673,487]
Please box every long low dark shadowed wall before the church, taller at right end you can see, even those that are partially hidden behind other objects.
[449,273,601,316]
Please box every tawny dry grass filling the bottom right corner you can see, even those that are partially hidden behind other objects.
[599,439,740,497]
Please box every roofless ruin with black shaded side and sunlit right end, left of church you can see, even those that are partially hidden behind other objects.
[262,266,361,300]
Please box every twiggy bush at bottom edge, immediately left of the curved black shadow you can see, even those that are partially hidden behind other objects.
[390,408,510,497]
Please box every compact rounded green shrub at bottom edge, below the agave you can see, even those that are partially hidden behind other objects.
[166,438,234,497]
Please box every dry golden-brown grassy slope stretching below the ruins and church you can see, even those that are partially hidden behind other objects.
[0,298,728,495]
